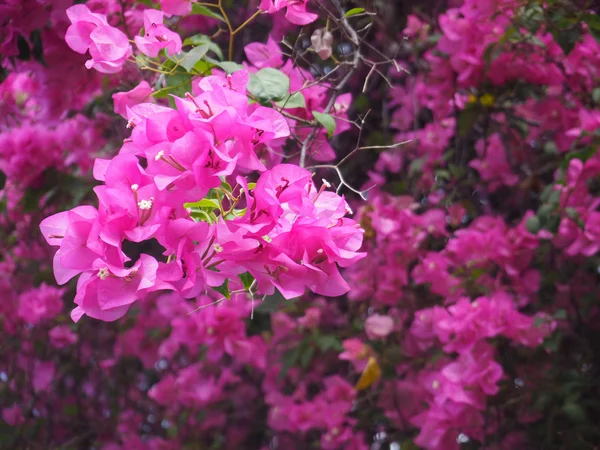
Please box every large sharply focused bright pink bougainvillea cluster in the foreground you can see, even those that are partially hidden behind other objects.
[40,66,364,321]
